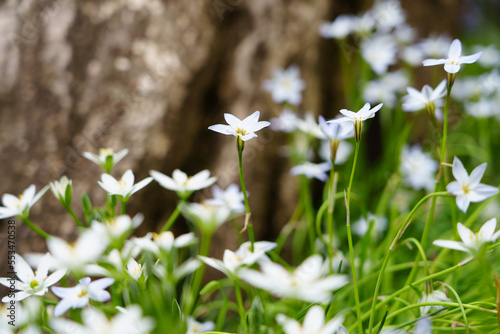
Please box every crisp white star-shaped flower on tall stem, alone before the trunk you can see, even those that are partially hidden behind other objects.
[208,111,271,141]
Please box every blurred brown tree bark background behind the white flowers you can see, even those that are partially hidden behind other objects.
[0,0,500,263]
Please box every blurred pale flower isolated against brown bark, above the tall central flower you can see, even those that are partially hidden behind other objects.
[262,65,306,105]
